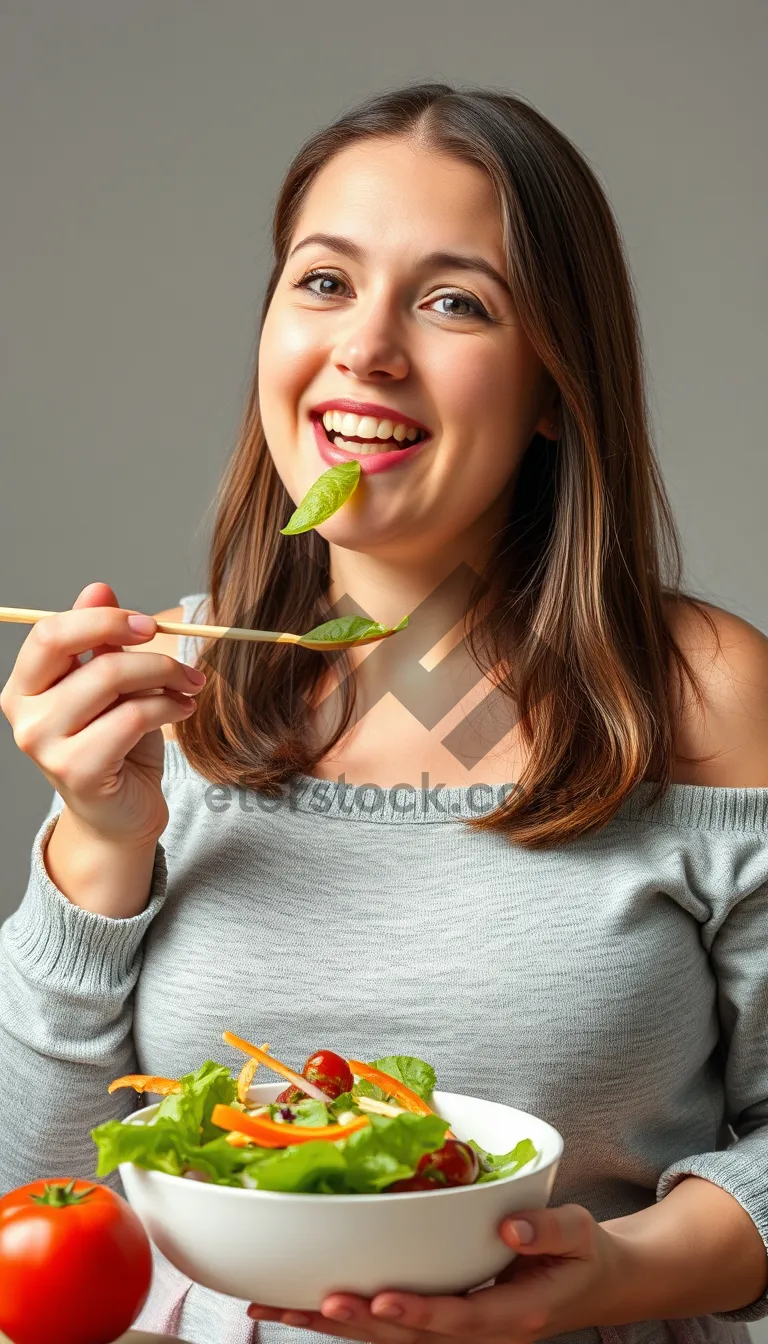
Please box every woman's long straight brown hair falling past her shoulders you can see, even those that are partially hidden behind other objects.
[176,83,717,848]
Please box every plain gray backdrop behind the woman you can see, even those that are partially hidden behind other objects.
[0,0,768,1341]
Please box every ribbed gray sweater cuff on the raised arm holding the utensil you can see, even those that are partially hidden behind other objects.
[3,814,168,995]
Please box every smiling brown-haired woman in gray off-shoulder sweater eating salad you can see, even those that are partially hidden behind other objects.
[0,85,768,1344]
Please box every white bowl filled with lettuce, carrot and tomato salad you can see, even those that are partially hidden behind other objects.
[91,1031,564,1309]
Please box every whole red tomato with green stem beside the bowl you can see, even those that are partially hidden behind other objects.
[0,1177,152,1344]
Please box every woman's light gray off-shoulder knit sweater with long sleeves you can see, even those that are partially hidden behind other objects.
[0,594,768,1344]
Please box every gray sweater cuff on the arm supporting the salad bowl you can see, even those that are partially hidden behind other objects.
[656,1145,768,1322]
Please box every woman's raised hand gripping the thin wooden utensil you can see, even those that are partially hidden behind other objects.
[0,583,204,848]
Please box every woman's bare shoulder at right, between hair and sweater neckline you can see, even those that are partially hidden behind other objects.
[667,602,768,789]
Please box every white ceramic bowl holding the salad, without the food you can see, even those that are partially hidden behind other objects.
[120,1083,564,1310]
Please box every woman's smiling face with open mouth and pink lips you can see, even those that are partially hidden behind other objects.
[258,138,554,562]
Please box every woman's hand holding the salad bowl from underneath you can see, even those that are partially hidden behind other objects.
[249,1204,628,1344]
